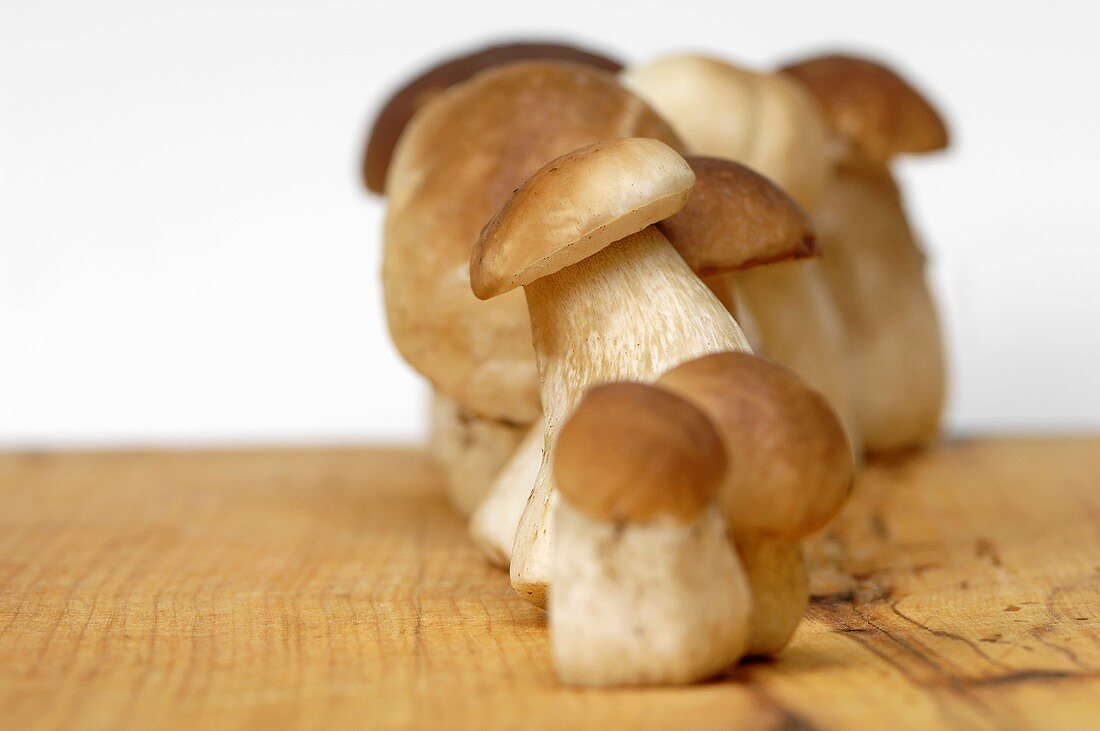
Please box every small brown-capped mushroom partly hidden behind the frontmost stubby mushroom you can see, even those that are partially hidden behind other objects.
[657,353,853,655]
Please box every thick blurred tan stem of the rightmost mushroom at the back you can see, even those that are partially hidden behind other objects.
[816,163,946,453]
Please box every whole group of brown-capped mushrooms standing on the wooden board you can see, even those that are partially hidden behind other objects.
[363,43,947,686]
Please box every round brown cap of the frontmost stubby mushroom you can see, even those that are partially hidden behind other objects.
[553,383,726,523]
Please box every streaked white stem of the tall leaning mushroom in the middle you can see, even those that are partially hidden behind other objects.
[512,226,749,606]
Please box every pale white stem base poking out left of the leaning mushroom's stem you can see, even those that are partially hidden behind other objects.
[470,419,546,568]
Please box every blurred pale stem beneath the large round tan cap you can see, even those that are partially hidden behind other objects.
[428,390,528,516]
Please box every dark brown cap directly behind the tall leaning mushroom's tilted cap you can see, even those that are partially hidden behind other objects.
[657,155,818,277]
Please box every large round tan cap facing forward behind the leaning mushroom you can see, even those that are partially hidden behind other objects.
[382,62,680,423]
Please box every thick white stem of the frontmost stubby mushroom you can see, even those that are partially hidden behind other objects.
[550,501,751,686]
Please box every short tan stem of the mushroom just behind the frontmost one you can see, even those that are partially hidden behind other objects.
[737,535,810,655]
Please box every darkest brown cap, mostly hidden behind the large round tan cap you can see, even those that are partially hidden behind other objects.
[362,42,623,193]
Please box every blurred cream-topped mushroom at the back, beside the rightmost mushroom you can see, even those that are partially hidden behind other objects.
[624,55,860,452]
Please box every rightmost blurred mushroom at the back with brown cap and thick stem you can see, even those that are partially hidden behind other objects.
[785,56,947,452]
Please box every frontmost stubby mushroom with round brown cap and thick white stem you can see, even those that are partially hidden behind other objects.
[550,383,751,686]
